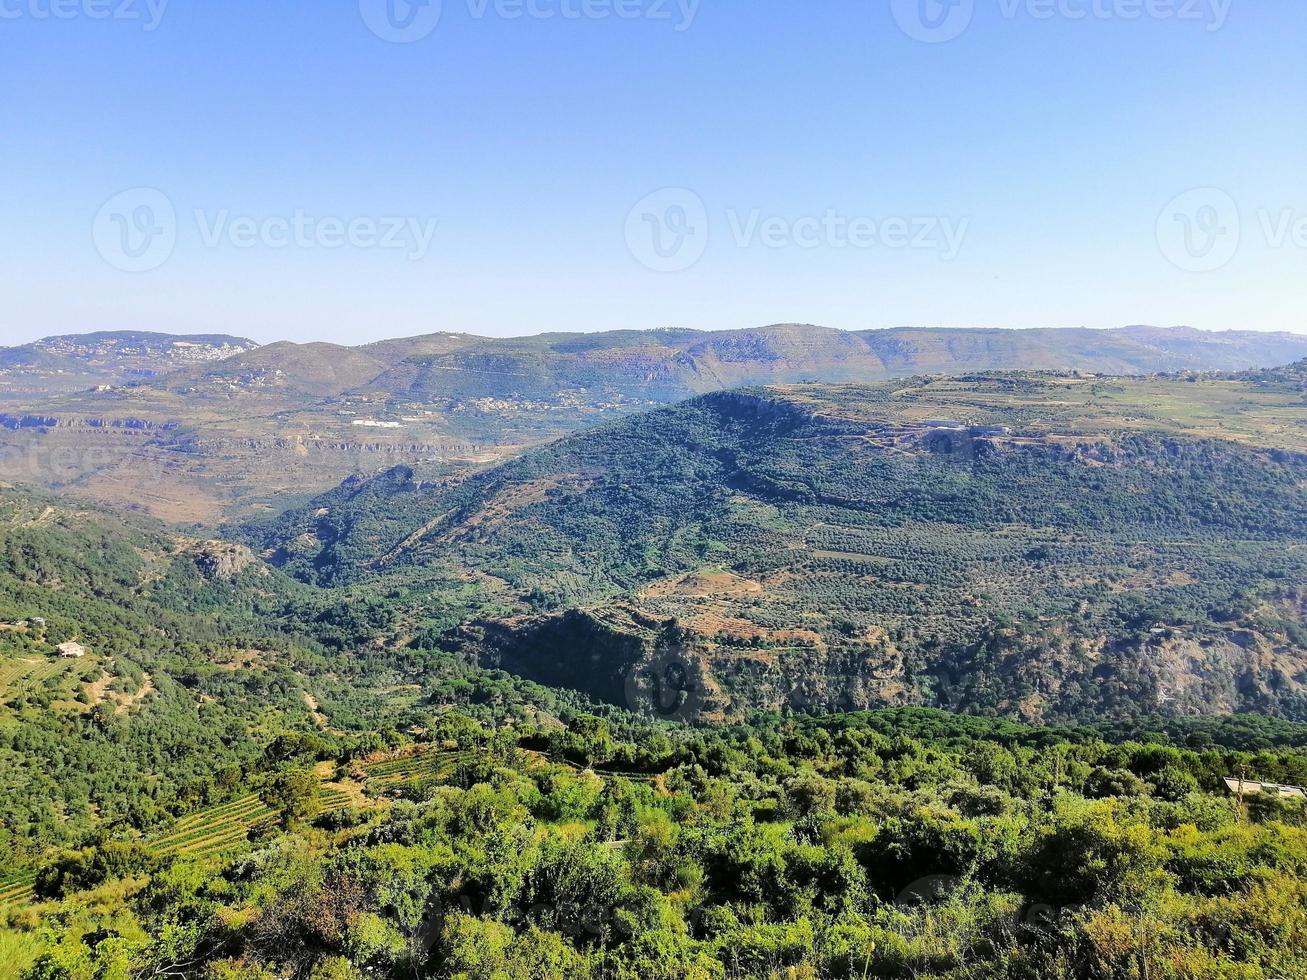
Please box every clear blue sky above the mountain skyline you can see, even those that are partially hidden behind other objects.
[0,0,1307,344]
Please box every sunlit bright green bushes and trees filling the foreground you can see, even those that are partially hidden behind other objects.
[13,716,1307,980]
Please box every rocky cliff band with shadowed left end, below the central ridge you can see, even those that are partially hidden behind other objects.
[451,602,1307,723]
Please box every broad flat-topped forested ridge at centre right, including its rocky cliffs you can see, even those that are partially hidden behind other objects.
[248,374,1307,719]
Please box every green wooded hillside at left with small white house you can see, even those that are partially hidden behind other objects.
[0,483,629,872]
